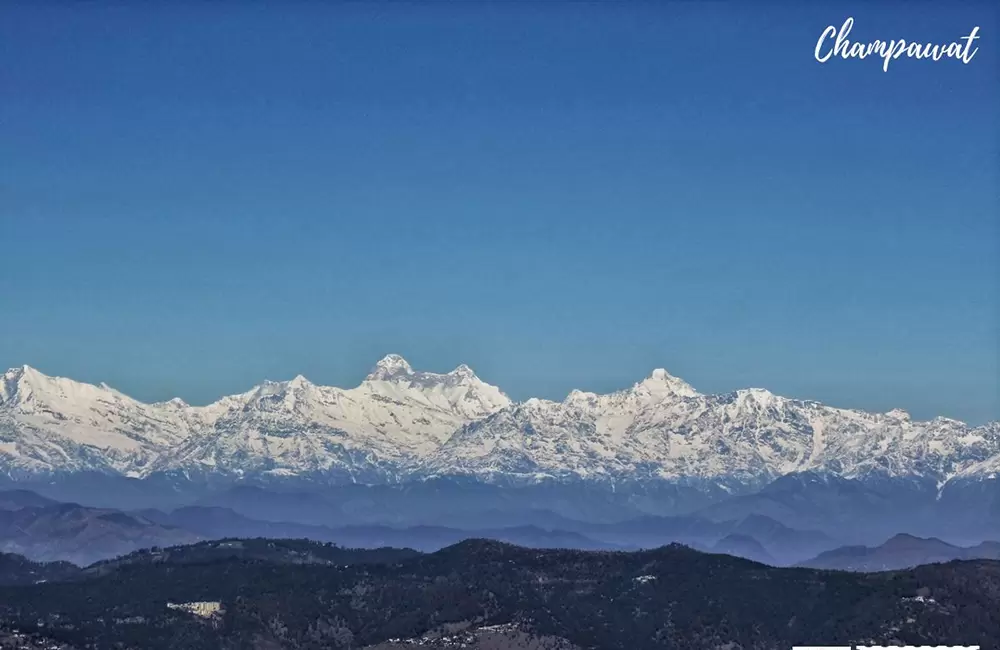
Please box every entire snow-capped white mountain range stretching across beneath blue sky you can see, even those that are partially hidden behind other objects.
[0,355,1000,485]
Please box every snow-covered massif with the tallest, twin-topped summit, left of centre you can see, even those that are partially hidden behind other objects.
[151,354,510,480]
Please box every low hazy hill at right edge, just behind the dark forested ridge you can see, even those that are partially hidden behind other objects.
[799,534,1000,572]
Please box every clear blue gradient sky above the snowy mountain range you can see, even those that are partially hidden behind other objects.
[0,0,1000,422]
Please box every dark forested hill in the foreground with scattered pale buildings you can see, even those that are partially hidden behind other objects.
[0,540,1000,650]
